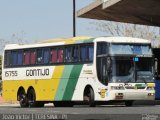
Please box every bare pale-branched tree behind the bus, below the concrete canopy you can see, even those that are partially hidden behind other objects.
[91,21,160,47]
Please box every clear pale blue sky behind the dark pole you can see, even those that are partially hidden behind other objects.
[0,0,105,44]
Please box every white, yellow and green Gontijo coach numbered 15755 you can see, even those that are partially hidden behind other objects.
[2,37,155,107]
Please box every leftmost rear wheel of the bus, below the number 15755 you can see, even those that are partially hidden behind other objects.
[18,89,29,108]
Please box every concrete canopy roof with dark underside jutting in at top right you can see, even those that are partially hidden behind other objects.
[77,0,160,26]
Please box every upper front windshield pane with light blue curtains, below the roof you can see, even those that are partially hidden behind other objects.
[110,43,152,55]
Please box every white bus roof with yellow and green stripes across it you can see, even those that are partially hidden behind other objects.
[5,37,151,50]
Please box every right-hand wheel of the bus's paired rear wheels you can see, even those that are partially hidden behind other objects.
[27,88,38,107]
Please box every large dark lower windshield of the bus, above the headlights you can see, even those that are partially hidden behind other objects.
[111,57,153,82]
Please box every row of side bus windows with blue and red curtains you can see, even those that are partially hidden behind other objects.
[5,44,94,66]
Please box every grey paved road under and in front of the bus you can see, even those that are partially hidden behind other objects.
[0,103,160,120]
